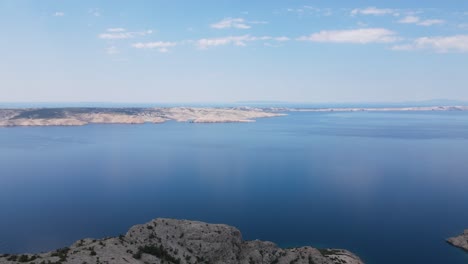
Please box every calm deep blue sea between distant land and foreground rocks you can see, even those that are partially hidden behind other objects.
[0,112,468,264]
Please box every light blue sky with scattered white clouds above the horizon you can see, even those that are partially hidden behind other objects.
[0,0,468,103]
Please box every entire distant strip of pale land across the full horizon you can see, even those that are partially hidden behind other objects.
[0,106,468,127]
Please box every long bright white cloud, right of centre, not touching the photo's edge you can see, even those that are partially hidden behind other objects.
[298,28,399,44]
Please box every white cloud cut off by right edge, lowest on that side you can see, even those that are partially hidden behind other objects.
[392,35,468,53]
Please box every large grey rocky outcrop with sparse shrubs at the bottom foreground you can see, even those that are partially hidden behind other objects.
[0,219,363,264]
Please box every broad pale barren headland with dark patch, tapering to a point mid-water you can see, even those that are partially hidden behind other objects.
[0,107,283,126]
